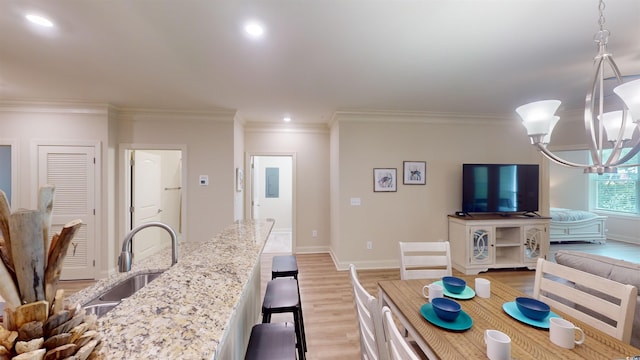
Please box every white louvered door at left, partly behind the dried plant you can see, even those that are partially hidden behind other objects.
[38,145,96,280]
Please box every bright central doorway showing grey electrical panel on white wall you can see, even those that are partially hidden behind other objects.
[249,154,295,254]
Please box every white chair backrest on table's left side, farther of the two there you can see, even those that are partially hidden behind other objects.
[349,264,389,360]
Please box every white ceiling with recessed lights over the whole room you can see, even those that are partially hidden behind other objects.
[0,0,640,123]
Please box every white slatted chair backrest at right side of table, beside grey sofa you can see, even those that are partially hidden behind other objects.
[533,259,638,344]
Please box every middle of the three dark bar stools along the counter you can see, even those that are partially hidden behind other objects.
[262,278,307,360]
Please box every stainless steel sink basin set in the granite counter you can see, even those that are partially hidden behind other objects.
[83,271,164,317]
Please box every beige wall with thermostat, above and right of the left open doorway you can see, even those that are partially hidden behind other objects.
[117,110,235,245]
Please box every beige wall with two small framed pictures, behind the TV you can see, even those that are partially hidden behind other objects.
[331,113,548,269]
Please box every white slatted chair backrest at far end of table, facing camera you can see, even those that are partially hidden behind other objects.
[399,241,451,280]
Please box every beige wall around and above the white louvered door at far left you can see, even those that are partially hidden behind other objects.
[0,101,110,277]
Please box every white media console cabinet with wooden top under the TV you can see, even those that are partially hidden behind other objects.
[448,214,550,275]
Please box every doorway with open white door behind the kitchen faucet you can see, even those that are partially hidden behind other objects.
[118,145,186,261]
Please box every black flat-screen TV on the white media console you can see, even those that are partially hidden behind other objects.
[462,164,539,213]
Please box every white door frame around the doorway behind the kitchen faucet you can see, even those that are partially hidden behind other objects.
[114,143,188,254]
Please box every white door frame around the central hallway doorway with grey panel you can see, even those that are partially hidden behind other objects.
[244,151,297,254]
